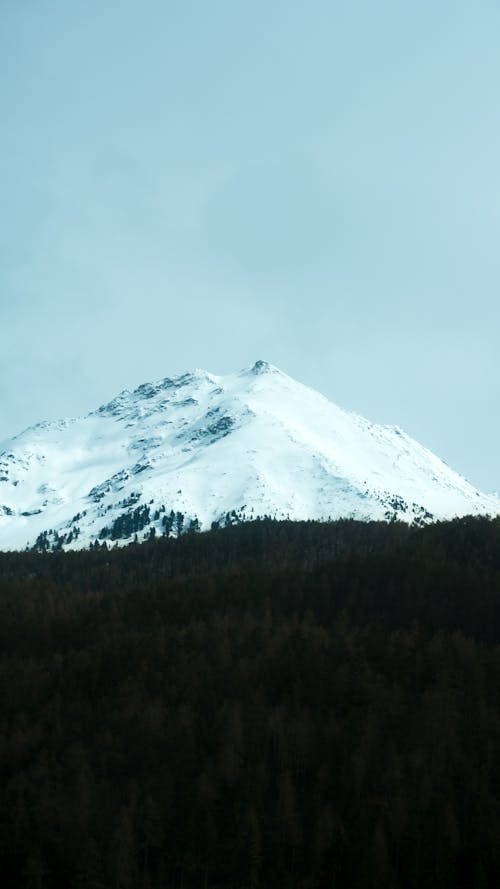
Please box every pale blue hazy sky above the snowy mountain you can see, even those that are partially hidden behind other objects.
[0,0,500,491]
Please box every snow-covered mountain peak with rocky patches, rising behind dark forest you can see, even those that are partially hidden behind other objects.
[0,361,500,550]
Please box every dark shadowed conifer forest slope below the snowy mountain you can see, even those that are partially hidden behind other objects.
[0,518,500,889]
